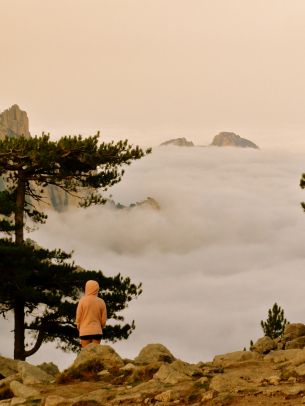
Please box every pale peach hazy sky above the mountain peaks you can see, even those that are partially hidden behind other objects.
[0,0,305,149]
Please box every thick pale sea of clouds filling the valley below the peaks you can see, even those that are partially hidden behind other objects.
[0,147,305,368]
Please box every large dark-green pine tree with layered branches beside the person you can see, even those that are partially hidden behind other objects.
[0,134,150,359]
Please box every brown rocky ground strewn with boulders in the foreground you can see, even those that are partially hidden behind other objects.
[0,324,305,406]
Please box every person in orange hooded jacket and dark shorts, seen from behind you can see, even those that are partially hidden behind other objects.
[76,280,107,348]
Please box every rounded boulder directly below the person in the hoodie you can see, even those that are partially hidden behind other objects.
[72,344,124,369]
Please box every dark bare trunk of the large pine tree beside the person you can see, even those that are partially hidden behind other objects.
[14,178,25,360]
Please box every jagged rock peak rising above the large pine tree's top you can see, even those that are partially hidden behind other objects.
[0,104,31,139]
